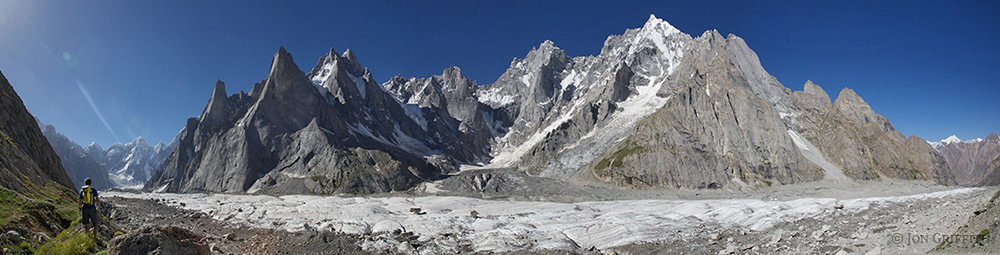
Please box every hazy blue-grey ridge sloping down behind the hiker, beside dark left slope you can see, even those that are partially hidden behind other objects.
[39,123,112,189]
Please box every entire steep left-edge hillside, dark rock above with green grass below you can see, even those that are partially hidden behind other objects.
[0,69,77,239]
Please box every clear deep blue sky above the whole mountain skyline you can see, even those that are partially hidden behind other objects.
[0,0,1000,148]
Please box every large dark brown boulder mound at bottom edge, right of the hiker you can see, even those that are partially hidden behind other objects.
[108,226,212,254]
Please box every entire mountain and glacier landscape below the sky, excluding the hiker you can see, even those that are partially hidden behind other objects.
[0,15,1000,254]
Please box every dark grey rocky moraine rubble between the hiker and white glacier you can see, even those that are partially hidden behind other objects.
[103,194,371,254]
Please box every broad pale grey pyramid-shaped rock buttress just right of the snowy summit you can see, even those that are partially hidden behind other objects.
[591,31,824,189]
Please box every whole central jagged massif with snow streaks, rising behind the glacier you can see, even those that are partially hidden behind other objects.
[145,15,954,193]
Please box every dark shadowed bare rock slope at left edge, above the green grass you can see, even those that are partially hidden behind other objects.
[0,69,74,193]
